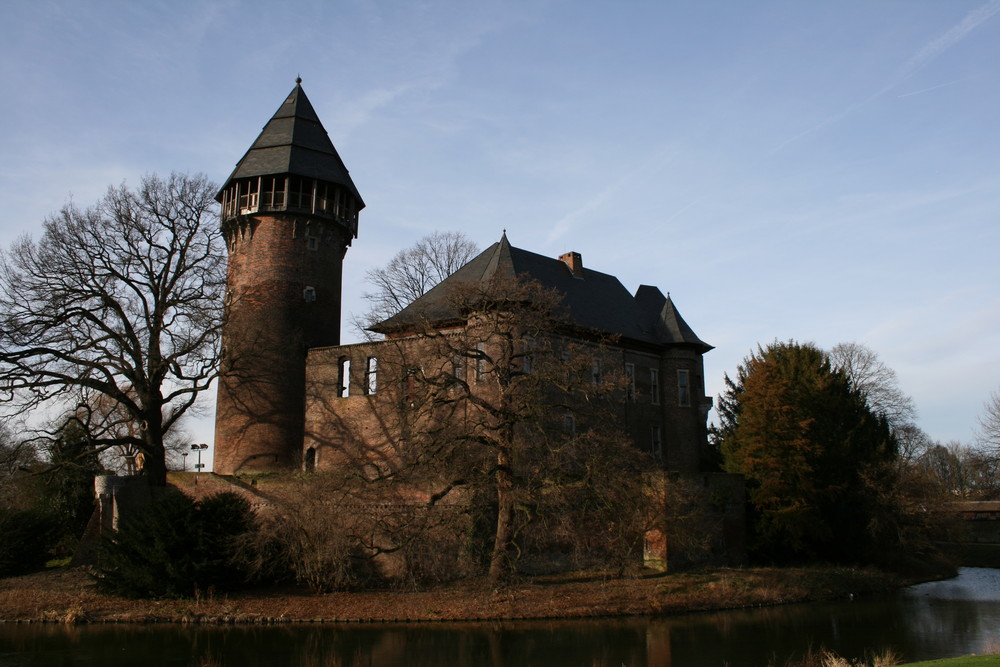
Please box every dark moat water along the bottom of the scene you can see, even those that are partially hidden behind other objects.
[0,568,1000,667]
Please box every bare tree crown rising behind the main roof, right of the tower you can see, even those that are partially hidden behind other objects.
[353,232,479,333]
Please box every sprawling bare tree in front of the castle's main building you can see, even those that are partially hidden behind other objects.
[307,277,652,583]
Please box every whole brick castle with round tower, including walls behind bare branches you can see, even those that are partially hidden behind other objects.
[214,79,742,561]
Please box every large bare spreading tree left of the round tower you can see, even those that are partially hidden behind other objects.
[0,174,225,484]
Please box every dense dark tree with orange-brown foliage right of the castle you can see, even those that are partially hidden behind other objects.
[717,341,896,562]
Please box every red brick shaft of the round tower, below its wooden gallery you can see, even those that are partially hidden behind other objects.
[215,214,349,474]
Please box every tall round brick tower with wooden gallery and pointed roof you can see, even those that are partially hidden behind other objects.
[215,79,365,474]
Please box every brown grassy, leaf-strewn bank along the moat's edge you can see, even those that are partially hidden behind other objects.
[0,568,920,623]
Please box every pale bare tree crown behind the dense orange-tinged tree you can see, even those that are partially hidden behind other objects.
[829,343,917,432]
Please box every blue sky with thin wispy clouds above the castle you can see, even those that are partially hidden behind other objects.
[0,0,1000,454]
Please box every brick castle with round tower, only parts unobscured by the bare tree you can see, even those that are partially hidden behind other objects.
[215,79,712,474]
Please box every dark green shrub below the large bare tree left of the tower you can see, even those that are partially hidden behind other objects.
[95,493,254,597]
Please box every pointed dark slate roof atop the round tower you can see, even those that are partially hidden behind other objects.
[217,79,365,205]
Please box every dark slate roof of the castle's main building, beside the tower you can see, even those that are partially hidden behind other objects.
[372,233,712,352]
